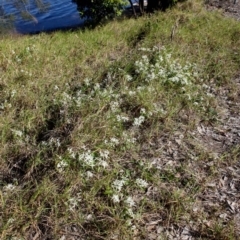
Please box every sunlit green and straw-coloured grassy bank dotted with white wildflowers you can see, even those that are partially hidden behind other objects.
[0,1,240,240]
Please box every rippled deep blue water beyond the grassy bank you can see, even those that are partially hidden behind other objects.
[0,0,84,34]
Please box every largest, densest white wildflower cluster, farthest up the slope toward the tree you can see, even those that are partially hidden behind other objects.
[135,48,196,86]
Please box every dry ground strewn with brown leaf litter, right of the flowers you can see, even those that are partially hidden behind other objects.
[139,74,240,240]
